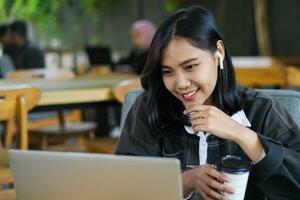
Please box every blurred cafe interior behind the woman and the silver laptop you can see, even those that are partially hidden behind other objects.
[0,0,300,200]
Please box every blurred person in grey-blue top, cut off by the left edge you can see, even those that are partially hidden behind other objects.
[0,24,15,78]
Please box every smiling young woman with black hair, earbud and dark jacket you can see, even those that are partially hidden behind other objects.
[116,6,300,200]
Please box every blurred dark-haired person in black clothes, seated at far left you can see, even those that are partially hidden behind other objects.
[4,21,45,69]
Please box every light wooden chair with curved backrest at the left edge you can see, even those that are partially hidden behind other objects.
[0,86,41,199]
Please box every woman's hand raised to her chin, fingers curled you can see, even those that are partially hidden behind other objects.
[184,105,244,140]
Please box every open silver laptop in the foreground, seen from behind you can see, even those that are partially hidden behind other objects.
[9,150,183,200]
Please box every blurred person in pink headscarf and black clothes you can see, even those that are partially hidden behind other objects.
[117,20,156,74]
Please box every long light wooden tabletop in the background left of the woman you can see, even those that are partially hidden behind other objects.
[0,73,138,106]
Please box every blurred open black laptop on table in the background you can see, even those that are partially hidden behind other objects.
[85,46,113,69]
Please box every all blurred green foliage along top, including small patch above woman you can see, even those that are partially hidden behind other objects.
[0,0,183,47]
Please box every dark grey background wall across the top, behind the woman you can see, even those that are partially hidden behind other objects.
[51,0,300,57]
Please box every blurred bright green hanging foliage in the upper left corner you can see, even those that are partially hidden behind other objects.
[0,0,106,46]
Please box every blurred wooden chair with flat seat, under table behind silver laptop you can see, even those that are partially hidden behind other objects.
[29,101,97,151]
